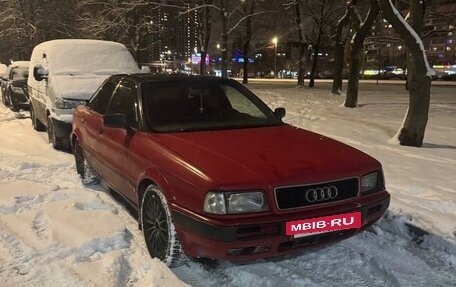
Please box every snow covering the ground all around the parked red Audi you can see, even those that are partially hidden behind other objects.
[0,84,456,287]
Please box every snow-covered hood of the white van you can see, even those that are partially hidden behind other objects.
[49,74,110,100]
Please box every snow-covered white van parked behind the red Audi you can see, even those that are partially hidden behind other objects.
[27,39,140,150]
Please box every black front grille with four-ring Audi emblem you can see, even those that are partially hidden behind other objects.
[274,178,358,209]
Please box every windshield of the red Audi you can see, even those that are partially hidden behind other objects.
[141,79,281,132]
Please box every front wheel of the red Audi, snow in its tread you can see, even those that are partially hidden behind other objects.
[141,184,184,267]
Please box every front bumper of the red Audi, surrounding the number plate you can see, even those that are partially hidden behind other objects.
[172,191,390,261]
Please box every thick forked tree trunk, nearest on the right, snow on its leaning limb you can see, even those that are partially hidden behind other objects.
[379,0,433,147]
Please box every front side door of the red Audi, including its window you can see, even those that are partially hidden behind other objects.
[97,80,138,202]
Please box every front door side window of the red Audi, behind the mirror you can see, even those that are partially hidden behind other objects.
[107,81,138,128]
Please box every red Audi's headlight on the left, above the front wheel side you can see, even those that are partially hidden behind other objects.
[203,191,269,214]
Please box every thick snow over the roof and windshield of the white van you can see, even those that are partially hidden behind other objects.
[34,39,139,75]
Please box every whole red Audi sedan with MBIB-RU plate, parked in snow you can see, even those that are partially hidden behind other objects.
[71,74,390,265]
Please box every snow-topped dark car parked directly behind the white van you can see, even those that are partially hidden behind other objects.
[2,61,30,111]
